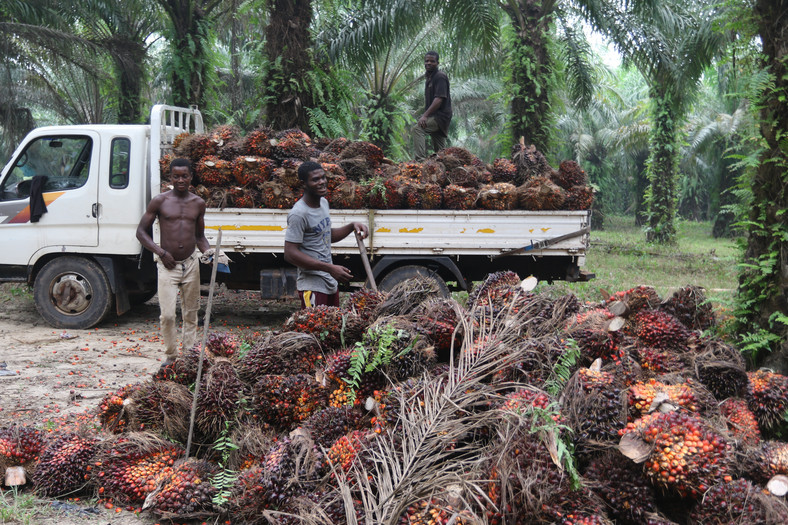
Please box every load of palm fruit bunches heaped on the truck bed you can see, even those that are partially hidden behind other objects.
[160,126,593,210]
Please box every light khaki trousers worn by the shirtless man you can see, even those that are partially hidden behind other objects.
[156,251,200,359]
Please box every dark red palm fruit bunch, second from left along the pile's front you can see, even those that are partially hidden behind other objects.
[33,433,99,497]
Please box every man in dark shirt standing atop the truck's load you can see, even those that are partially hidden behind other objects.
[413,51,451,160]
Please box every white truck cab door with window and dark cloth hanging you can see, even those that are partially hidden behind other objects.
[0,130,100,264]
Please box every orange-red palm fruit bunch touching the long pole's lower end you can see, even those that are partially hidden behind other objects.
[143,458,217,519]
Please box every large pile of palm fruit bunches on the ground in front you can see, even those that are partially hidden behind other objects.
[0,272,788,525]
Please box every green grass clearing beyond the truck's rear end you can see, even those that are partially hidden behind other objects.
[540,217,740,310]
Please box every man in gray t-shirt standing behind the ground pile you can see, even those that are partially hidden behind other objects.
[285,161,369,308]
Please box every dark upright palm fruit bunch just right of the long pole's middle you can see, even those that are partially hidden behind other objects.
[195,359,245,438]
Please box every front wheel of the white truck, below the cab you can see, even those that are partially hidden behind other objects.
[33,256,113,329]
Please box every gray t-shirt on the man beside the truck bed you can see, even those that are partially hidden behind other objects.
[285,198,338,294]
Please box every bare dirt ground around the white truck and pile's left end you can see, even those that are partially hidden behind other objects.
[0,284,298,525]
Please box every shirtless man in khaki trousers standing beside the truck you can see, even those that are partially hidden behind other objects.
[137,158,210,366]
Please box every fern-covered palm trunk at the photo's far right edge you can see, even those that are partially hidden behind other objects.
[737,0,788,374]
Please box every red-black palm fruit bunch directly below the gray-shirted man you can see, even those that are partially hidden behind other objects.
[284,305,363,348]
